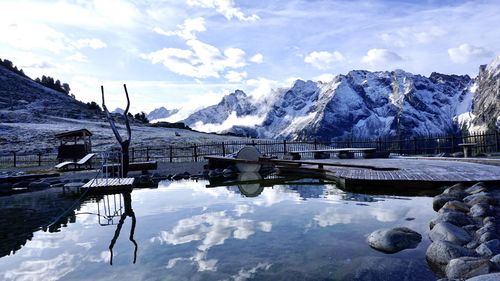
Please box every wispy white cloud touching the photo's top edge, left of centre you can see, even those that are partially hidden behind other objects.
[187,0,259,22]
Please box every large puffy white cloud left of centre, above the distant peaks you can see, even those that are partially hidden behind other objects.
[141,39,246,78]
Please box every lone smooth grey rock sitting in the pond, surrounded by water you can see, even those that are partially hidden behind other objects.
[368,227,422,253]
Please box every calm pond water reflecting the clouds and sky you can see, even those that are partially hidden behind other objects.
[0,180,436,280]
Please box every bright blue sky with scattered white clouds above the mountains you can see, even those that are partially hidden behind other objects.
[0,0,500,114]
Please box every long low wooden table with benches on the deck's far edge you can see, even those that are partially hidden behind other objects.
[285,147,377,160]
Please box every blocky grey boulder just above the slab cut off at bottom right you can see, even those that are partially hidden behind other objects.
[446,257,490,279]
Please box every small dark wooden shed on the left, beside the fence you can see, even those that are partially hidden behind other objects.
[55,129,92,162]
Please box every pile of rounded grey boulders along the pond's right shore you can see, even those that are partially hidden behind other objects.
[426,182,500,281]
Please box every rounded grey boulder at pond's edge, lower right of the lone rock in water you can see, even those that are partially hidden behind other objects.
[425,241,475,265]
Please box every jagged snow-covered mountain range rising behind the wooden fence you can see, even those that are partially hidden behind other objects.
[184,66,482,140]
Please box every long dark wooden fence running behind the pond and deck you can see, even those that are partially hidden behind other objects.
[0,131,500,168]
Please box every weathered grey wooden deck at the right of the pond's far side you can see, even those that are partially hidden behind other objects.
[278,159,500,189]
